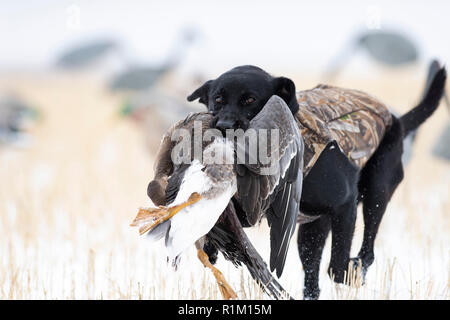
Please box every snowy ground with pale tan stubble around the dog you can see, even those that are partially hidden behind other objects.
[0,74,450,299]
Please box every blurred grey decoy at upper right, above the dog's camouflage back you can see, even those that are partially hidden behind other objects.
[325,30,419,81]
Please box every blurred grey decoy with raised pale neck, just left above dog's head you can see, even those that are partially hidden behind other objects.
[110,28,199,91]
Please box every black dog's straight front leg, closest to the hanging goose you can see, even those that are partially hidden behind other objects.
[297,214,331,300]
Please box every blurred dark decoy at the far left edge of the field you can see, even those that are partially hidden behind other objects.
[0,95,39,147]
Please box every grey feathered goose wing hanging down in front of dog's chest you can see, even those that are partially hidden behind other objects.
[236,96,304,277]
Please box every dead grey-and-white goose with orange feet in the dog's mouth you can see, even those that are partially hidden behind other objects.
[132,96,304,298]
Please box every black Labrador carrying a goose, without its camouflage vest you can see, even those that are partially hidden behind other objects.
[187,66,446,299]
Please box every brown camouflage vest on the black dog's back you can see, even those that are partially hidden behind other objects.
[295,84,392,176]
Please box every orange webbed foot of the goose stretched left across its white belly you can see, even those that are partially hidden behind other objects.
[130,192,202,235]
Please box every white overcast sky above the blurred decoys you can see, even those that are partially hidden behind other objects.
[0,0,450,74]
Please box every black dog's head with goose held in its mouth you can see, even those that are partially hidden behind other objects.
[187,66,298,131]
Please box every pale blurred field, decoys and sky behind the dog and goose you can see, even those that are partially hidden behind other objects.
[0,0,450,299]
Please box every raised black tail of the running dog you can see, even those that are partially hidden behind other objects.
[400,63,447,137]
